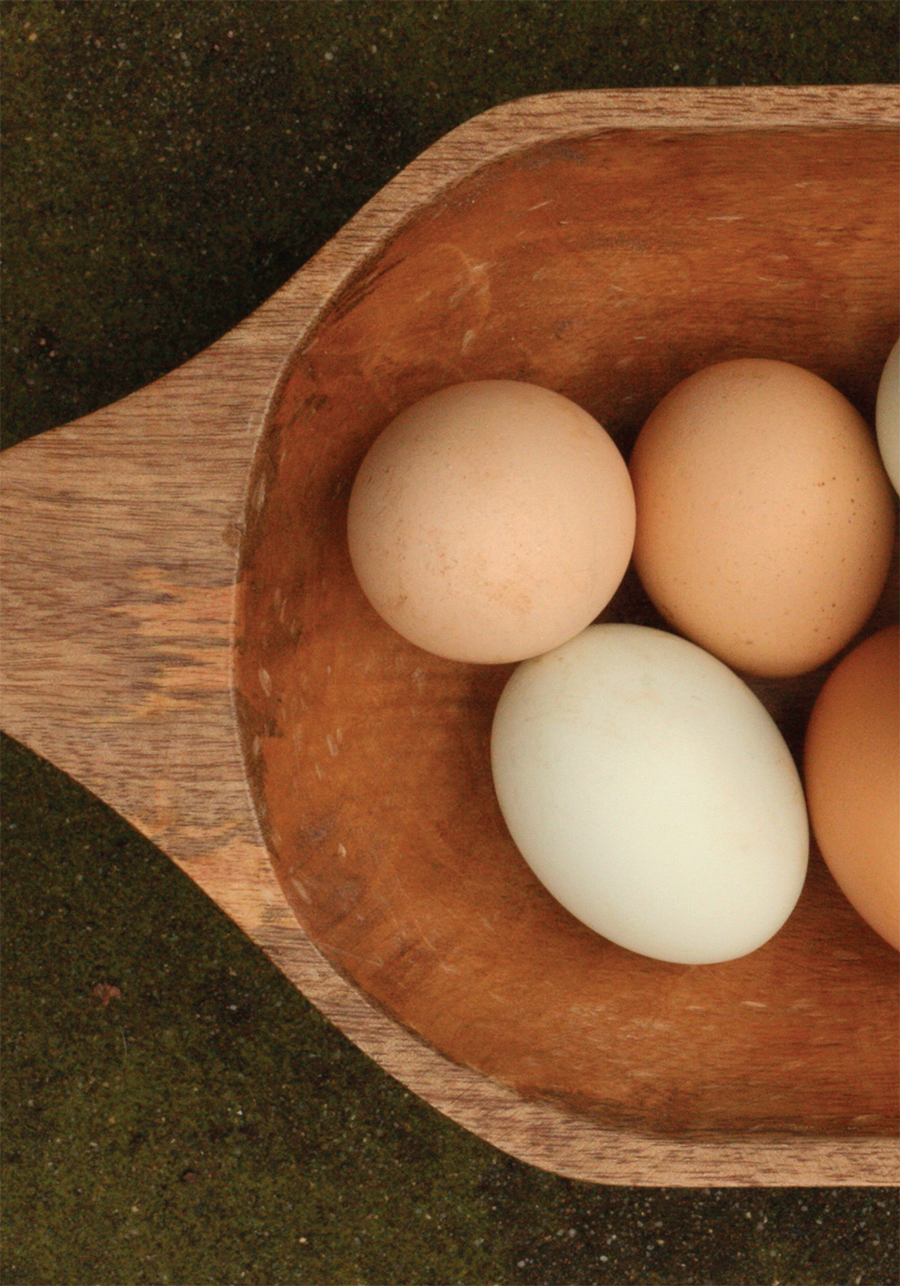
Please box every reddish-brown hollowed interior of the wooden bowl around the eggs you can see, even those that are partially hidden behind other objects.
[237,130,897,1136]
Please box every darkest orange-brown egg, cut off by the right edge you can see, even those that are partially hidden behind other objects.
[804,625,900,948]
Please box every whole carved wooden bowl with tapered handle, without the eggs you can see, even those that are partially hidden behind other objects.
[3,86,897,1186]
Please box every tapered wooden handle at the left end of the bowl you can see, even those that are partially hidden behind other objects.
[0,309,291,932]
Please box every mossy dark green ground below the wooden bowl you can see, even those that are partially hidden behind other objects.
[0,738,897,1286]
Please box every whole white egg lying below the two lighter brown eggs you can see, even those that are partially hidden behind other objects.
[491,625,809,965]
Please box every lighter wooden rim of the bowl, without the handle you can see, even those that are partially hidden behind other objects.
[234,86,899,1186]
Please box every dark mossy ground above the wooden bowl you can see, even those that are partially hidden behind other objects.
[1,0,897,445]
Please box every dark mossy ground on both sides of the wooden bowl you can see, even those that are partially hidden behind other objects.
[0,0,897,1286]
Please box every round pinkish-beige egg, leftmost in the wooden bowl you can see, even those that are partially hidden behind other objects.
[347,379,634,662]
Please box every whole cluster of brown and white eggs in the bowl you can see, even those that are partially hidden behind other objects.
[348,345,900,963]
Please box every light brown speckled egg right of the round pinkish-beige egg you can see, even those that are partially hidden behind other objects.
[631,359,894,675]
